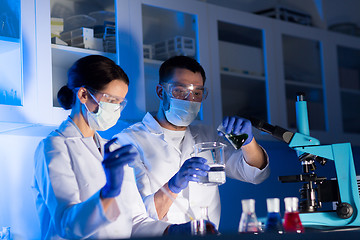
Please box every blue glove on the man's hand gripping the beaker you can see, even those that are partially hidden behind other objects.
[168,157,210,193]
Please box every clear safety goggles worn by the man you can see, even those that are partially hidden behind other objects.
[161,83,208,102]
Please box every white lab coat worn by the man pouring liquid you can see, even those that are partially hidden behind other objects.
[116,113,270,227]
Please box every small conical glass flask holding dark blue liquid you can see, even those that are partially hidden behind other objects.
[265,198,284,234]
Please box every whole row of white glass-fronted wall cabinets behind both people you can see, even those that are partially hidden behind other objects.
[0,0,360,144]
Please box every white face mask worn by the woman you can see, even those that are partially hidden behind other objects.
[84,102,122,131]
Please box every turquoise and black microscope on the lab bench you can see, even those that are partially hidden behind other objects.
[251,93,360,227]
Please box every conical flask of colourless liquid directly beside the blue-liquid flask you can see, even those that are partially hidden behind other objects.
[239,199,261,233]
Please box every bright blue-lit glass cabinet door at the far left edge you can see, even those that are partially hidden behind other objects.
[0,0,37,126]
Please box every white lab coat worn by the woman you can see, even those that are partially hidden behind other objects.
[34,118,169,239]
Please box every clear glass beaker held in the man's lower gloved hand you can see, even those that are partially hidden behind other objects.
[194,142,226,185]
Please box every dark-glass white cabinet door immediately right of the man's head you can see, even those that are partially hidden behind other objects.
[209,6,277,127]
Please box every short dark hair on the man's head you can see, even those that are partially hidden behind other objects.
[159,56,206,84]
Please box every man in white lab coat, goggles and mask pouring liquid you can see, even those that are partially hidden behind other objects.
[117,56,269,227]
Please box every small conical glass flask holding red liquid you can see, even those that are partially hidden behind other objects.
[283,197,304,233]
